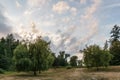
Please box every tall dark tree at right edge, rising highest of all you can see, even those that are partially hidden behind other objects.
[109,25,120,65]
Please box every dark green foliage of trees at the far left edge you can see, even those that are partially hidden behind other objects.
[0,34,19,70]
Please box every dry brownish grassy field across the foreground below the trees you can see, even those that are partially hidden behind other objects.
[0,67,120,80]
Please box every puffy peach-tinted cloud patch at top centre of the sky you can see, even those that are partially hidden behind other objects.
[52,1,70,14]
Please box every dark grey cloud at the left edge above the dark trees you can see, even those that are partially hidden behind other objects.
[0,5,12,35]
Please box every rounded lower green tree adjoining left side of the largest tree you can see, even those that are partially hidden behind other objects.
[13,44,32,71]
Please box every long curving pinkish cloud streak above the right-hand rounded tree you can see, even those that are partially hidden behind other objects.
[69,0,100,50]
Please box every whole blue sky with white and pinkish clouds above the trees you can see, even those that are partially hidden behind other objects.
[0,0,120,56]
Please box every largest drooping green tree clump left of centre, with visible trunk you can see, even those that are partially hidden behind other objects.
[14,37,54,75]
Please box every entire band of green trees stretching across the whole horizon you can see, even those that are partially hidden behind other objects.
[0,25,120,75]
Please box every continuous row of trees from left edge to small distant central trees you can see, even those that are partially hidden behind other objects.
[0,34,77,75]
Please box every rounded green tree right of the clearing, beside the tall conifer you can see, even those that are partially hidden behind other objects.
[83,45,112,70]
